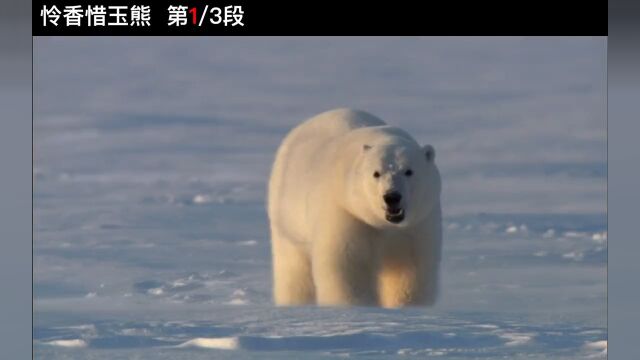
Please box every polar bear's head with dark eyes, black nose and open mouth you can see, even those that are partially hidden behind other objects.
[345,132,441,227]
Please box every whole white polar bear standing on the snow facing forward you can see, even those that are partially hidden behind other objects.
[268,109,442,307]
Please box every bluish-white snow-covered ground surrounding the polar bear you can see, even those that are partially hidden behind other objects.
[34,38,607,359]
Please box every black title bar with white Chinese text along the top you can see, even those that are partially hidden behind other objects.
[32,0,607,36]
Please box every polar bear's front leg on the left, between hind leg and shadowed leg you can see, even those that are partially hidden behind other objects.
[312,218,377,306]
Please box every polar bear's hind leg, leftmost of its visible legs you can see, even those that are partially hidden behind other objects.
[271,232,315,306]
